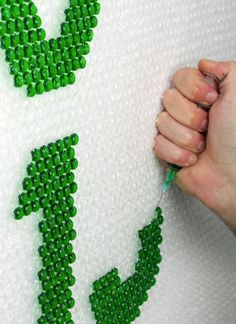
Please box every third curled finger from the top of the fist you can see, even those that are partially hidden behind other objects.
[157,111,205,153]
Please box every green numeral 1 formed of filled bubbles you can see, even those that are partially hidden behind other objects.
[14,134,79,324]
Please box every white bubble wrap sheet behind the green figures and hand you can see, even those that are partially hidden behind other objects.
[0,0,236,324]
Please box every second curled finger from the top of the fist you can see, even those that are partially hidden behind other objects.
[162,89,208,132]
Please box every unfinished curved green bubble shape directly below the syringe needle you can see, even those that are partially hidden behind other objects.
[90,207,163,324]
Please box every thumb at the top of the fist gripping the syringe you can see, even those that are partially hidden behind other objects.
[198,59,236,94]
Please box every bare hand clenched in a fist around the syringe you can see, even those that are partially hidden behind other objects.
[154,60,236,232]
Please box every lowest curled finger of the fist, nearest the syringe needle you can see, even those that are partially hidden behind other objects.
[154,135,197,167]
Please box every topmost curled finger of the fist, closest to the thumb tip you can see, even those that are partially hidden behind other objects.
[173,68,218,106]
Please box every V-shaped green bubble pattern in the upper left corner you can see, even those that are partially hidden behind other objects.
[0,0,101,97]
